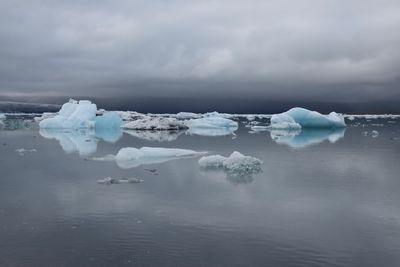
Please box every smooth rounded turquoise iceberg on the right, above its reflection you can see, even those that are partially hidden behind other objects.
[270,108,346,129]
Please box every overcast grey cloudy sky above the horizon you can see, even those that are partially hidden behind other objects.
[0,0,400,111]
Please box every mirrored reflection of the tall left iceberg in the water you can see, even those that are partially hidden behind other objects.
[39,128,122,156]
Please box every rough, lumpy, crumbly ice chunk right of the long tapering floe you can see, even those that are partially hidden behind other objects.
[199,151,263,174]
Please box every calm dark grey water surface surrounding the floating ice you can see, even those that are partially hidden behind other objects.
[0,120,400,267]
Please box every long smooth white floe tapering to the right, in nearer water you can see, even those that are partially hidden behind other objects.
[112,147,206,169]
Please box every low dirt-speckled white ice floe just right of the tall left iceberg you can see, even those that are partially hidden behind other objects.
[122,116,188,131]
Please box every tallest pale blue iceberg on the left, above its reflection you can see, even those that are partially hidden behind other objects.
[37,99,122,129]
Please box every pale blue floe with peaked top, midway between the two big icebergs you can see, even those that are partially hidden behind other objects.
[184,112,238,136]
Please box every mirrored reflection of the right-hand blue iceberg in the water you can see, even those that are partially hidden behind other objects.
[270,128,346,148]
